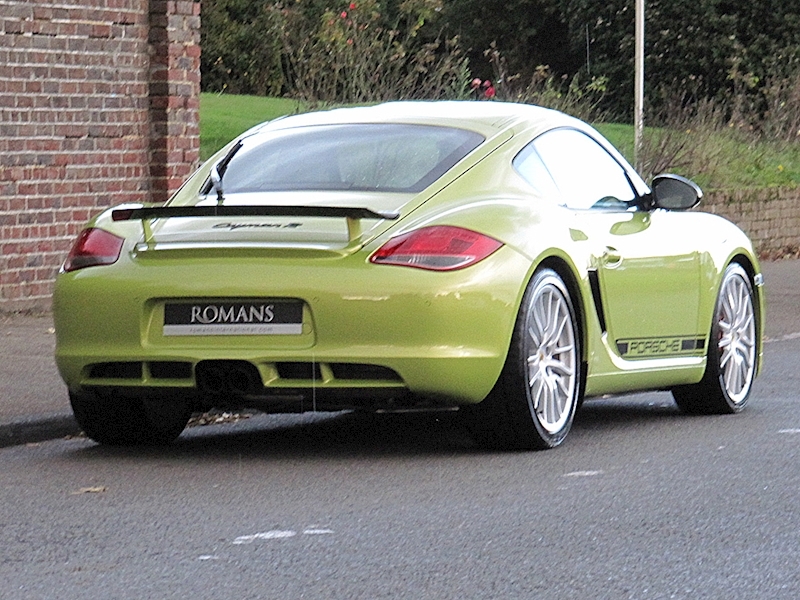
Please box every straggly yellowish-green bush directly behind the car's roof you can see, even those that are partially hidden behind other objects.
[273,0,469,103]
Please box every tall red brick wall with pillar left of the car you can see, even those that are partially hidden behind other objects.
[0,0,200,311]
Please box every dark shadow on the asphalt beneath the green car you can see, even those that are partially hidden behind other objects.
[61,394,685,460]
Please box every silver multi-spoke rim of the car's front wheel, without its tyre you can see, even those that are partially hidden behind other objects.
[717,272,756,404]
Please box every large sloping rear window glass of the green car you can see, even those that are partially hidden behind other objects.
[216,124,484,194]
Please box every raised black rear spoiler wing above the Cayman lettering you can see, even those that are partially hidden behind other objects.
[111,205,400,242]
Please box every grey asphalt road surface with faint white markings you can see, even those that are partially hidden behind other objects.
[0,336,800,600]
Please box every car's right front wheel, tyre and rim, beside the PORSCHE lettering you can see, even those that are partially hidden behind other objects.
[672,263,759,414]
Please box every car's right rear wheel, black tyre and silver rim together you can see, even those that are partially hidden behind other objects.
[465,269,583,450]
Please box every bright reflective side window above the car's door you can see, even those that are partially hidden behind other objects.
[533,129,636,210]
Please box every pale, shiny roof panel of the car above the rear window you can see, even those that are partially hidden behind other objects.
[248,100,586,137]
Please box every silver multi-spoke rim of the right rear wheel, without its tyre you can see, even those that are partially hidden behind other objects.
[524,278,578,433]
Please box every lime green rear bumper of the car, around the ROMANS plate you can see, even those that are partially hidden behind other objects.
[53,248,529,404]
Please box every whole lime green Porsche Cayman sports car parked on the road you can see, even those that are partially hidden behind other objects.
[53,102,764,449]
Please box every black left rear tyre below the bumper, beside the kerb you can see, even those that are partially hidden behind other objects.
[69,392,192,446]
